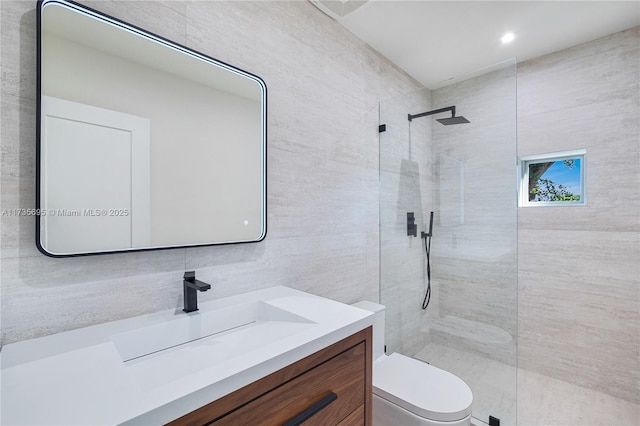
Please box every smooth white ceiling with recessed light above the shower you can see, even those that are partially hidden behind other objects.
[310,0,640,89]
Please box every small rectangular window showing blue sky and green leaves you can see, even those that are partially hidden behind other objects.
[518,149,587,206]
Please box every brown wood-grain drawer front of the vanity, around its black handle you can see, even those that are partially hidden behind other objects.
[214,343,366,426]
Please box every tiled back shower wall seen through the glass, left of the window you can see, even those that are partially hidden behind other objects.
[431,63,517,365]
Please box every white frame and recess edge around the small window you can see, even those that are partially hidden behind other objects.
[518,149,587,207]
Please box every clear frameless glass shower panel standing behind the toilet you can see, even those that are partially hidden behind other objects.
[380,61,517,425]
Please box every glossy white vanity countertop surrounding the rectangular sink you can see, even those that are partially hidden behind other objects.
[0,286,373,425]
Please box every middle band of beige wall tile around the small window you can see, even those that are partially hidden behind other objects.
[518,95,640,232]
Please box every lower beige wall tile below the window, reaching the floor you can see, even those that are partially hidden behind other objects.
[518,230,640,403]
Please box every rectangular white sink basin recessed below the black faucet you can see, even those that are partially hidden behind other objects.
[111,300,315,363]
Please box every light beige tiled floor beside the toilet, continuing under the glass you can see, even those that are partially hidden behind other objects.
[415,343,640,426]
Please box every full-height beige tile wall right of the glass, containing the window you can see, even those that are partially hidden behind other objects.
[518,27,640,403]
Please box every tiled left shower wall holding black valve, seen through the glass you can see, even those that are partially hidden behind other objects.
[379,91,433,355]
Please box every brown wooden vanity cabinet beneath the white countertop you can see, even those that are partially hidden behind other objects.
[169,327,372,426]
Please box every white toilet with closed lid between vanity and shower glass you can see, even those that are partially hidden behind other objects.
[353,301,473,426]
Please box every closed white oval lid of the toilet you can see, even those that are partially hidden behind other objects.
[373,353,473,422]
